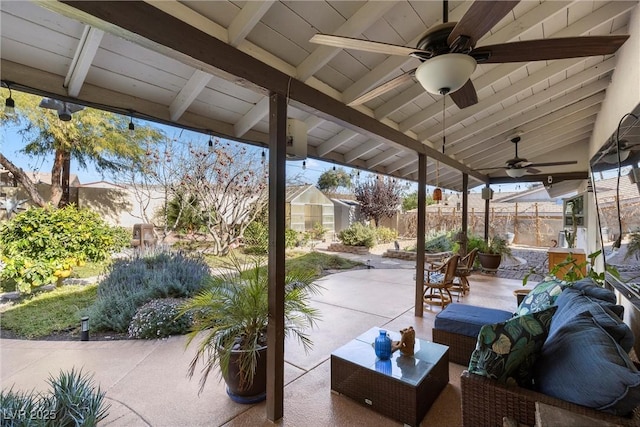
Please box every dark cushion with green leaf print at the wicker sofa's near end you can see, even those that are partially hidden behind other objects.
[469,306,557,387]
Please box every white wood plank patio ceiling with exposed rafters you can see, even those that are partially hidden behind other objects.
[0,0,638,190]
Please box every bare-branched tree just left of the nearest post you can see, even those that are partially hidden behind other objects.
[120,138,268,255]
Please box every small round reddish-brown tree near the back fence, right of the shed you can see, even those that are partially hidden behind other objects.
[354,176,404,227]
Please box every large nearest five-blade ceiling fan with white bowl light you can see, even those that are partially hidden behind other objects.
[309,0,629,109]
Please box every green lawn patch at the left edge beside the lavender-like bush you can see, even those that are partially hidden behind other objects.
[0,285,98,339]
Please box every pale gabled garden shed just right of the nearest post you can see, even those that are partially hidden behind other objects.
[285,184,335,233]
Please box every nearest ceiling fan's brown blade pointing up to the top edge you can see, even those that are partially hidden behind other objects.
[447,0,520,48]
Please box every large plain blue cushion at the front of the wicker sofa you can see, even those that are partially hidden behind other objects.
[536,311,640,415]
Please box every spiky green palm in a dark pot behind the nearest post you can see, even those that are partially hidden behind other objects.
[179,255,321,403]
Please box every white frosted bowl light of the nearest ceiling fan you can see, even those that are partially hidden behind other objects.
[416,53,477,95]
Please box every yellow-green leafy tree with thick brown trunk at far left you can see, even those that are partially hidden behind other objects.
[0,91,162,207]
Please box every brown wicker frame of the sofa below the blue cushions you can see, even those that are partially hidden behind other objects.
[460,370,640,426]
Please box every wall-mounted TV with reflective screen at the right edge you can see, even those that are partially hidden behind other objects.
[591,105,640,290]
